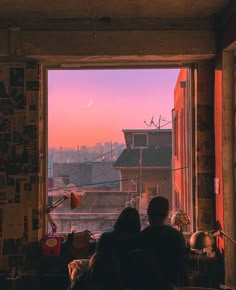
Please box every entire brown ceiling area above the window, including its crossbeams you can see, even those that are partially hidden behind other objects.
[0,0,232,66]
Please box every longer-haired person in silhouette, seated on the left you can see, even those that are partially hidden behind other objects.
[89,207,141,290]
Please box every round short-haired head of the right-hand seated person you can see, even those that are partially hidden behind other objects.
[147,196,169,225]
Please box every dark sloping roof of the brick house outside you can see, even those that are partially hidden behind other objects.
[113,146,172,167]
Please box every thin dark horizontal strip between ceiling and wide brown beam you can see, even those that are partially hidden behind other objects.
[0,16,215,31]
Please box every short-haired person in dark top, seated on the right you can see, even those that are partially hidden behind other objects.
[138,196,186,289]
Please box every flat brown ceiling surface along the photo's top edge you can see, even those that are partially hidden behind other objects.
[0,0,230,21]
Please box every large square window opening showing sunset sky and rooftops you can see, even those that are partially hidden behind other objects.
[46,67,192,236]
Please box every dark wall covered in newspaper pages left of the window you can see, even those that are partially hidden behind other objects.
[0,60,42,268]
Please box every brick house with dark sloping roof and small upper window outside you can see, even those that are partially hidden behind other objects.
[114,129,172,204]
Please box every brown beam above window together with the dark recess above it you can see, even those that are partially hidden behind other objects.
[0,18,216,64]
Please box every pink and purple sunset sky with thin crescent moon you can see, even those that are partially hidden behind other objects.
[48,69,179,148]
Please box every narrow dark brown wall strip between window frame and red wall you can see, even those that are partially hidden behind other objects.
[195,61,215,230]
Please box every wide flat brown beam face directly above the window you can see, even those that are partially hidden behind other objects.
[0,29,216,58]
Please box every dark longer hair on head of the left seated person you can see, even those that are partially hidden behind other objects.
[114,207,141,232]
